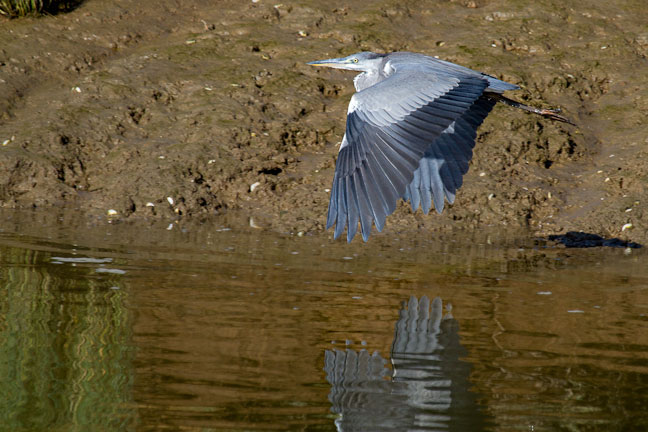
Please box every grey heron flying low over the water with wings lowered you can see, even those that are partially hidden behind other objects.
[308,52,571,242]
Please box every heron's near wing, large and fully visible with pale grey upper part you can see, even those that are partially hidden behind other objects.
[326,69,488,241]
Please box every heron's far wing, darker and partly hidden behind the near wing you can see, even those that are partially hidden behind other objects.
[403,96,497,214]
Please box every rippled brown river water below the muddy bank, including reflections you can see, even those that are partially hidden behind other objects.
[0,213,648,431]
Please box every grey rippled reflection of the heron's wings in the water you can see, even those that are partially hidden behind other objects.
[324,296,489,432]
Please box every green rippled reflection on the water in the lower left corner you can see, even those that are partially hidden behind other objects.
[0,245,136,431]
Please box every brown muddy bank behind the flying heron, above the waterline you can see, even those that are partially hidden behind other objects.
[0,0,648,243]
